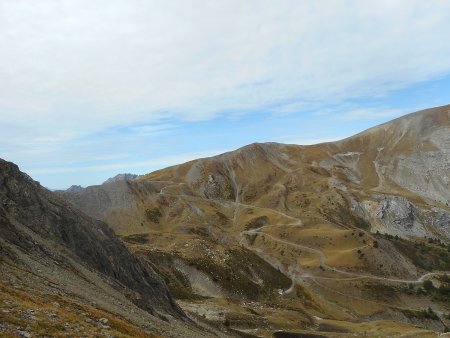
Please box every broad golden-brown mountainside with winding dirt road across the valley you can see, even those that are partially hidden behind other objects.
[62,106,450,336]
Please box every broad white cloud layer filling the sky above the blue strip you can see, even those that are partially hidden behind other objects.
[0,0,450,186]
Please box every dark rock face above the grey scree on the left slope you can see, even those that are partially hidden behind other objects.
[0,160,184,318]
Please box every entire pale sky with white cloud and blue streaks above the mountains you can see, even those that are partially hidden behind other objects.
[0,0,450,189]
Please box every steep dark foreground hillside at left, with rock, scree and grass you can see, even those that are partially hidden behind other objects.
[0,160,237,337]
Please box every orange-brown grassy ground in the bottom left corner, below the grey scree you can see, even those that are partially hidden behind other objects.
[0,283,154,338]
